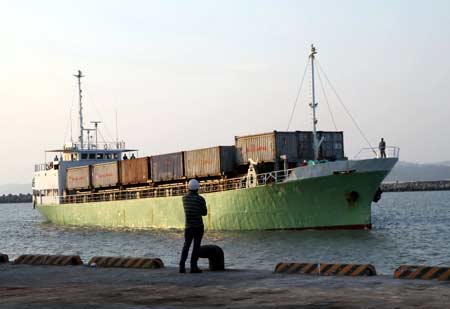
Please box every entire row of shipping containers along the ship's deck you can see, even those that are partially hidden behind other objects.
[66,131,345,192]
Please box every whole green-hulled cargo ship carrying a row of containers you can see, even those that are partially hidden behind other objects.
[32,47,399,230]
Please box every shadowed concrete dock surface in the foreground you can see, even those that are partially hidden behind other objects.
[0,263,450,308]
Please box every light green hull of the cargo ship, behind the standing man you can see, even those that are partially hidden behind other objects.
[37,163,395,230]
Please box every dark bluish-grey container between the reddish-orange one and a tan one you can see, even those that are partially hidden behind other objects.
[150,152,184,182]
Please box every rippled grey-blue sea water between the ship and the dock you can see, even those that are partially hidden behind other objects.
[0,191,450,274]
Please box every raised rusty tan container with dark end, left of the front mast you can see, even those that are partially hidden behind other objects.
[235,131,300,165]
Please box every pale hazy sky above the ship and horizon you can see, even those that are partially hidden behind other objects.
[0,0,450,184]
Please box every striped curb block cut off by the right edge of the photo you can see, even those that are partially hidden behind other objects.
[394,265,450,281]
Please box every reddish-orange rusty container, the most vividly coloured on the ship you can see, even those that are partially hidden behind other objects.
[119,157,149,186]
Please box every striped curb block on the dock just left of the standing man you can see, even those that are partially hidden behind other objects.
[89,256,164,269]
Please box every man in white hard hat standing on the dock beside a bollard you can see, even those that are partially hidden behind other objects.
[180,179,208,273]
